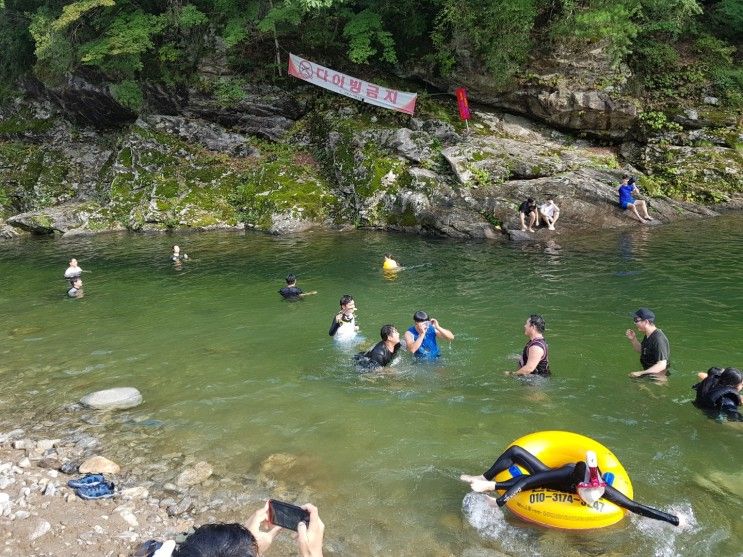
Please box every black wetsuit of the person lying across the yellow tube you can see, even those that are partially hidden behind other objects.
[483,445,679,526]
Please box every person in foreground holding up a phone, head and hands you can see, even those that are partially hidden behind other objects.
[169,502,325,557]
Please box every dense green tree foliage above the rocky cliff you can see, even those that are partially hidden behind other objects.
[0,0,743,109]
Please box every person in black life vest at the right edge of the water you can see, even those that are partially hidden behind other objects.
[692,367,743,422]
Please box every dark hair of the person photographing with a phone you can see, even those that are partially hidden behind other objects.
[173,523,258,557]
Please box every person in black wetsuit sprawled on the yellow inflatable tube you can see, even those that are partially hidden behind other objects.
[459,445,679,526]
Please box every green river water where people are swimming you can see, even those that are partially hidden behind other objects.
[0,215,743,556]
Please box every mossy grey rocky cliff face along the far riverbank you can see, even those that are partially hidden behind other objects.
[0,63,743,238]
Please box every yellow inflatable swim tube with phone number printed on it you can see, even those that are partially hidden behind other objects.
[494,431,633,530]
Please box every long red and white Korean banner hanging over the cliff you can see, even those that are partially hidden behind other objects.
[289,54,418,114]
